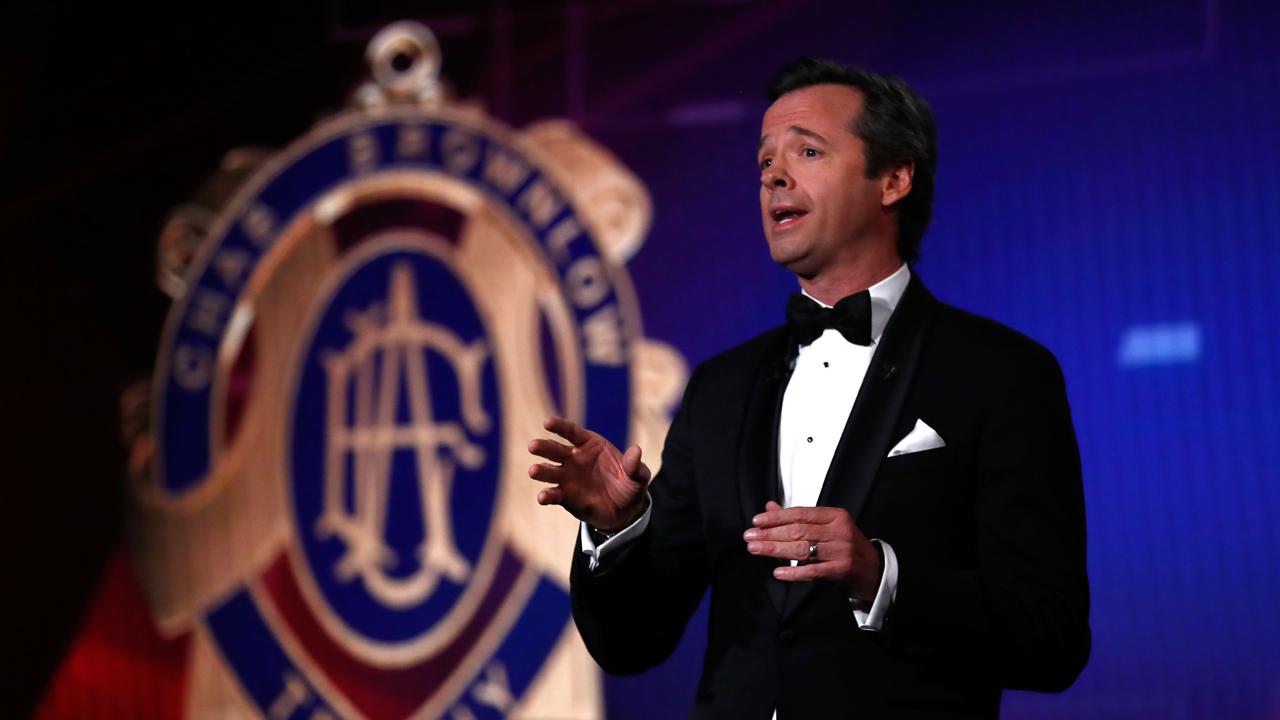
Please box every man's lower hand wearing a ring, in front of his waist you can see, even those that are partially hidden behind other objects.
[742,501,884,602]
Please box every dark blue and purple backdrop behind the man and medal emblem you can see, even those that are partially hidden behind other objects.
[0,0,1280,719]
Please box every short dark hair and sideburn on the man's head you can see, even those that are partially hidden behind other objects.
[768,58,938,261]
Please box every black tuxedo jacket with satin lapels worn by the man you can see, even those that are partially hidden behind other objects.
[571,274,1089,720]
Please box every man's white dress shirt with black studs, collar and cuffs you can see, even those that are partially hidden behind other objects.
[580,263,911,630]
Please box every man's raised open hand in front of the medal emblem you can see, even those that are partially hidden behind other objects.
[529,418,649,533]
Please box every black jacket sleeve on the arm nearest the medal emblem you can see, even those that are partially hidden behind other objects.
[570,370,708,674]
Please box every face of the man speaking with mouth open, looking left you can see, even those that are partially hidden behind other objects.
[756,85,892,278]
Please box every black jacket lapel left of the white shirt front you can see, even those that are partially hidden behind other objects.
[739,329,792,612]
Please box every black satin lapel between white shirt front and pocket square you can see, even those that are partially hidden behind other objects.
[783,273,937,615]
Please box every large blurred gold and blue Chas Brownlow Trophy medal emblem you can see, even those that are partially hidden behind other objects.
[134,26,684,720]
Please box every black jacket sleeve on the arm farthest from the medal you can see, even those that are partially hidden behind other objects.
[888,347,1091,692]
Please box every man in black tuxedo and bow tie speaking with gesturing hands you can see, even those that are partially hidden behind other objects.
[530,59,1089,720]
